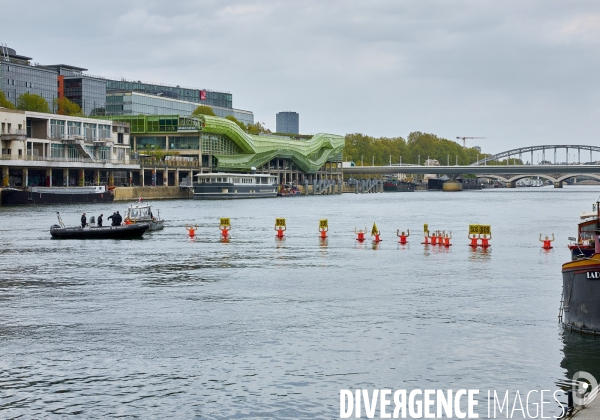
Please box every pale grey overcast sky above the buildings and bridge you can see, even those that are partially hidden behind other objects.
[0,0,600,152]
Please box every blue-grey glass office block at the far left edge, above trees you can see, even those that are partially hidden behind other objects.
[0,47,58,110]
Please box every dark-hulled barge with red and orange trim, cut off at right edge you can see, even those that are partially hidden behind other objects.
[559,200,600,334]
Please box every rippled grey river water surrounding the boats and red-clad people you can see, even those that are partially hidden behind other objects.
[0,186,600,418]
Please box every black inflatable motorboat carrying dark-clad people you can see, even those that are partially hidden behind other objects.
[50,212,150,239]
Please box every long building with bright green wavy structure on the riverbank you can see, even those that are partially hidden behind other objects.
[102,115,344,185]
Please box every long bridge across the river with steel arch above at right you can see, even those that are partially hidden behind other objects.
[344,145,600,188]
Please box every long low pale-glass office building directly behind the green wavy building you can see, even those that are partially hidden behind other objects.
[106,92,254,124]
